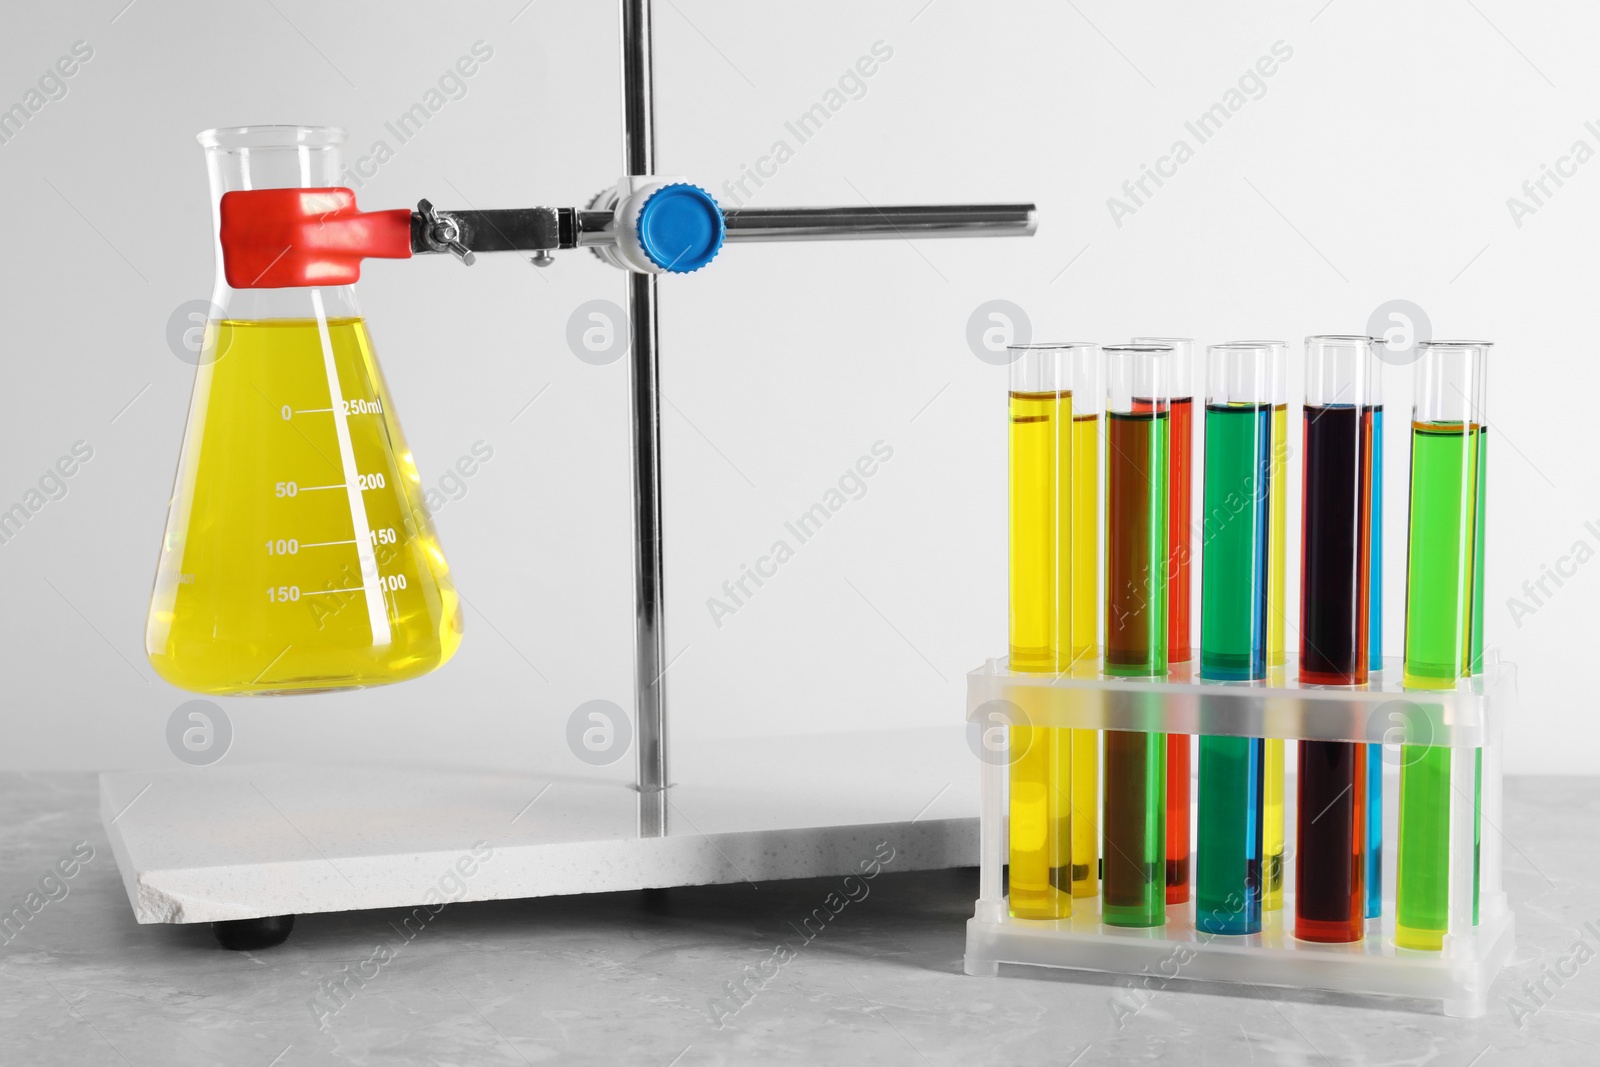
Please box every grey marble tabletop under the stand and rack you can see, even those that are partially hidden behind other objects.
[0,773,1600,1067]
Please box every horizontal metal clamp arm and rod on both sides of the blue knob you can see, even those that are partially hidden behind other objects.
[411,203,1038,256]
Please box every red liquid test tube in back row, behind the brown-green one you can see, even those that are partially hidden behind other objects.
[1133,338,1195,904]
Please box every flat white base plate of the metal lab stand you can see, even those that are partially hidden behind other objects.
[101,726,978,923]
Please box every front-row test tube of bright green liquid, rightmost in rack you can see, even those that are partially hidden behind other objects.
[1395,341,1491,952]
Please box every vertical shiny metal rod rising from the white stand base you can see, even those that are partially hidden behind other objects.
[621,0,669,837]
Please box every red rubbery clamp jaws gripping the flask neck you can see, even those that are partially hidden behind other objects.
[219,189,411,290]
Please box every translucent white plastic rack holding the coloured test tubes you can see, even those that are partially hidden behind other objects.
[965,656,1517,1017]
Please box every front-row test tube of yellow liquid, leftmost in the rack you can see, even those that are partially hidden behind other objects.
[1010,344,1072,918]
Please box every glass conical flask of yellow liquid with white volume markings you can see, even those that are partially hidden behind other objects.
[146,126,461,694]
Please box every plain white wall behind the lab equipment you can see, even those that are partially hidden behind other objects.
[0,0,1600,767]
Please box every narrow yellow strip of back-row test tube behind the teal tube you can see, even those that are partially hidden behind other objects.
[1235,341,1290,912]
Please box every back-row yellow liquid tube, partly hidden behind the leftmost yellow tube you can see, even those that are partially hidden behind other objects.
[1070,404,1101,897]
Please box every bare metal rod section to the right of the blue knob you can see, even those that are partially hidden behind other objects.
[723,203,1038,242]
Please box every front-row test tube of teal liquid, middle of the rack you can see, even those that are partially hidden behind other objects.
[1195,344,1274,934]
